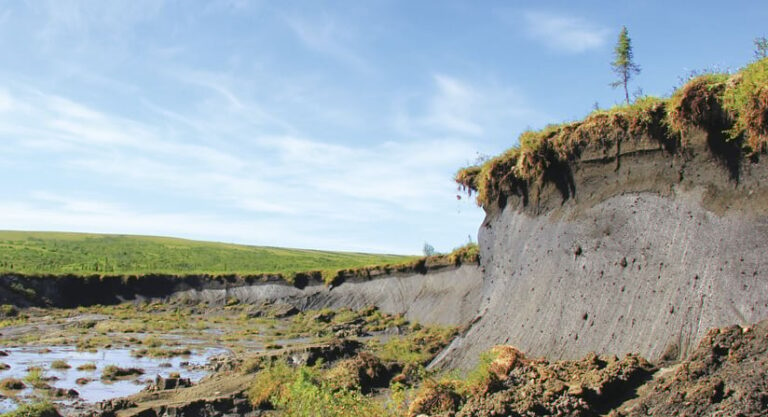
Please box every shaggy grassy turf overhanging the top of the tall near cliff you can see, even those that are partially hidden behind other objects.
[454,58,768,206]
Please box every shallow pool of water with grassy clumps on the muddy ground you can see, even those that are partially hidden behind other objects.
[0,346,227,413]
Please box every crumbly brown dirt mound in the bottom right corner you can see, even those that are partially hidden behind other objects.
[614,321,768,417]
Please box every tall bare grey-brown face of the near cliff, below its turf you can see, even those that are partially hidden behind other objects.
[434,131,768,368]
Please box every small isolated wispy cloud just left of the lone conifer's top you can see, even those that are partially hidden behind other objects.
[523,11,610,54]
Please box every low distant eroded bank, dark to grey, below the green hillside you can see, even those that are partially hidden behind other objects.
[0,265,482,325]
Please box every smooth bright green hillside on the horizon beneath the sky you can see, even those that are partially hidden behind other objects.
[0,231,415,275]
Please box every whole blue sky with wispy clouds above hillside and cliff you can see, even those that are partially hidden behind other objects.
[0,0,768,253]
